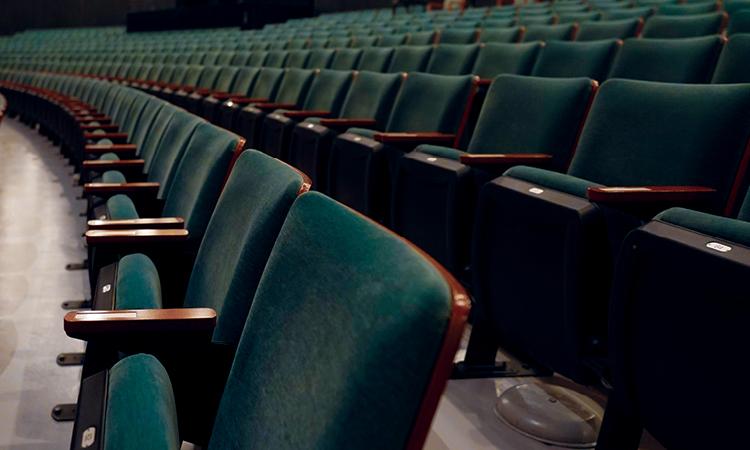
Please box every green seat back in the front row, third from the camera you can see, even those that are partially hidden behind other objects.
[162,122,240,242]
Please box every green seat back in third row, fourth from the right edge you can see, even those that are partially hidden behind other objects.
[471,42,542,79]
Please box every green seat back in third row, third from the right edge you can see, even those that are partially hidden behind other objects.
[532,39,620,80]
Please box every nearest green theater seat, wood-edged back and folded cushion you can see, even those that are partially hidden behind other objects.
[73,193,468,450]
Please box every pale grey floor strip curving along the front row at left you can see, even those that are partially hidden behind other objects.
[0,118,88,450]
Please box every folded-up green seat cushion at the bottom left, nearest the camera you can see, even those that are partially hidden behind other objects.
[103,354,181,450]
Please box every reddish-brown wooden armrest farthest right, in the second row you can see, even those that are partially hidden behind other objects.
[586,186,716,204]
